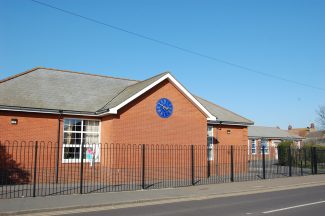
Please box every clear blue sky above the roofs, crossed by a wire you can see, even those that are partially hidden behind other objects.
[0,0,325,128]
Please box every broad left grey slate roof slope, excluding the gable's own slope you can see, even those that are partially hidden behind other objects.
[0,68,138,112]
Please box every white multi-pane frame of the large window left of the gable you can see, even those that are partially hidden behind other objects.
[62,118,101,163]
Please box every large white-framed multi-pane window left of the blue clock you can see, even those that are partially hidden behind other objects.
[62,119,100,163]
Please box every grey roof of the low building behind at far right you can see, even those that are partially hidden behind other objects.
[248,126,302,140]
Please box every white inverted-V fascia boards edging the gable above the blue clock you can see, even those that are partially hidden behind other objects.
[101,73,217,121]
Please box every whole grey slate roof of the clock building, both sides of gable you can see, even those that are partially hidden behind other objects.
[0,68,253,124]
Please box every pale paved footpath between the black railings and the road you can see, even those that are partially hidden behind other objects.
[0,175,325,215]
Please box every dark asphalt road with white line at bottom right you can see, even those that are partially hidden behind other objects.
[66,186,325,216]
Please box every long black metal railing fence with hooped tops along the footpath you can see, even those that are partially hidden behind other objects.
[0,141,325,198]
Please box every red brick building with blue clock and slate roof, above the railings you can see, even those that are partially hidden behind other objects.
[0,68,253,182]
